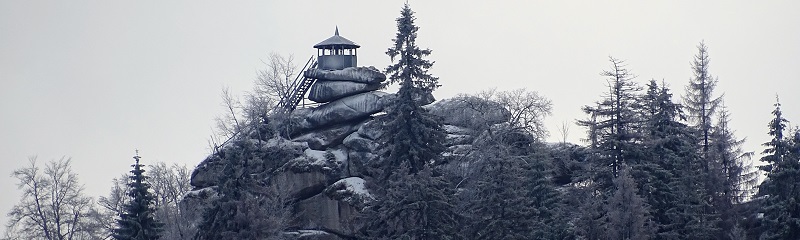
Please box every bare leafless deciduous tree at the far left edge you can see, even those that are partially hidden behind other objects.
[7,157,97,240]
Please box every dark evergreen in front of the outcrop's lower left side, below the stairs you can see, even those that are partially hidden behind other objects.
[194,140,289,240]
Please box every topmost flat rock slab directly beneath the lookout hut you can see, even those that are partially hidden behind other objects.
[303,67,386,84]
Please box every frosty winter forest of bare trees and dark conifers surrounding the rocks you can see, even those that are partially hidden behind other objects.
[3,4,800,240]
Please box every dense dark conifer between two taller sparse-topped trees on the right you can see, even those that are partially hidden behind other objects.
[631,80,718,239]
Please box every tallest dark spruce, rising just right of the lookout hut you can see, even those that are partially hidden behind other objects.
[382,4,445,173]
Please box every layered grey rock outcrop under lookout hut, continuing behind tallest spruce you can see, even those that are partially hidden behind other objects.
[182,63,509,240]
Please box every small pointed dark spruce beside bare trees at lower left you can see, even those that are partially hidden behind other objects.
[112,151,163,240]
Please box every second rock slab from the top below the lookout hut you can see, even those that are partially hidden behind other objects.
[308,80,381,103]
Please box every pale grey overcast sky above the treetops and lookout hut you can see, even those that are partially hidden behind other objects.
[0,0,800,232]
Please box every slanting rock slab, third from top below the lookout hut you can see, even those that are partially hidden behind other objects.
[306,91,387,128]
